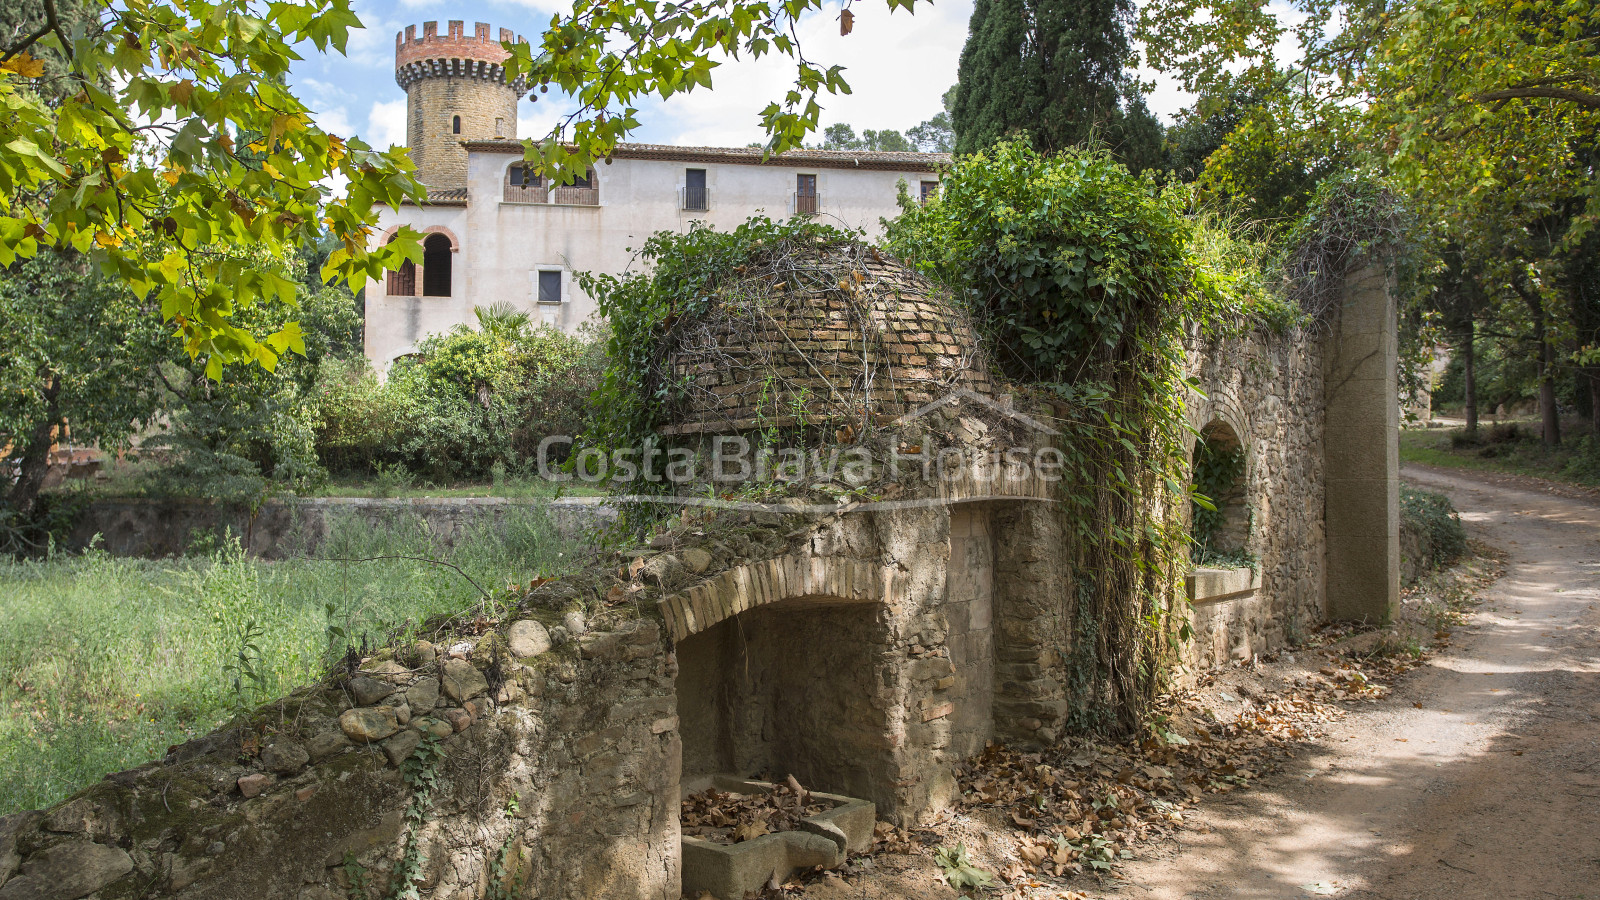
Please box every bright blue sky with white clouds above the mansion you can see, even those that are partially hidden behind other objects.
[290,0,1186,147]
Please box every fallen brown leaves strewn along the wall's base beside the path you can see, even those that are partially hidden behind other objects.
[742,546,1502,900]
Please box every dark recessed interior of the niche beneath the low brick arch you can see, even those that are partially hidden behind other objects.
[675,599,894,810]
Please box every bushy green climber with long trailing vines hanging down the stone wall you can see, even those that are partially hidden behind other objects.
[886,143,1209,732]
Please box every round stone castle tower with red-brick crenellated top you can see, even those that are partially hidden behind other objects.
[395,21,526,191]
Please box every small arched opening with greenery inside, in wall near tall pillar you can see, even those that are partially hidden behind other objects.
[1189,420,1250,565]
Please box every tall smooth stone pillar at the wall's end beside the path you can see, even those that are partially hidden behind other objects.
[1323,264,1400,623]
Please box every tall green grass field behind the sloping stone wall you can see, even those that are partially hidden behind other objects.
[0,509,574,815]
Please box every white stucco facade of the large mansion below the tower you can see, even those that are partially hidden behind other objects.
[365,141,947,372]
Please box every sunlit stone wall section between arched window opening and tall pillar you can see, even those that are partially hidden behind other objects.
[1189,323,1326,668]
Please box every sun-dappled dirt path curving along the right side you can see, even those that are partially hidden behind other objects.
[1115,466,1600,900]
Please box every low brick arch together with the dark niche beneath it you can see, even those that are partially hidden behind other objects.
[664,556,896,810]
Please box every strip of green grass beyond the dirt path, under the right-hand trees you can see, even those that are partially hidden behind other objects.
[1400,421,1600,487]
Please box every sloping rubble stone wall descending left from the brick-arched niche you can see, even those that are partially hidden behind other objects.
[0,621,680,900]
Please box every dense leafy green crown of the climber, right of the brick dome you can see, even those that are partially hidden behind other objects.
[885,143,1192,383]
